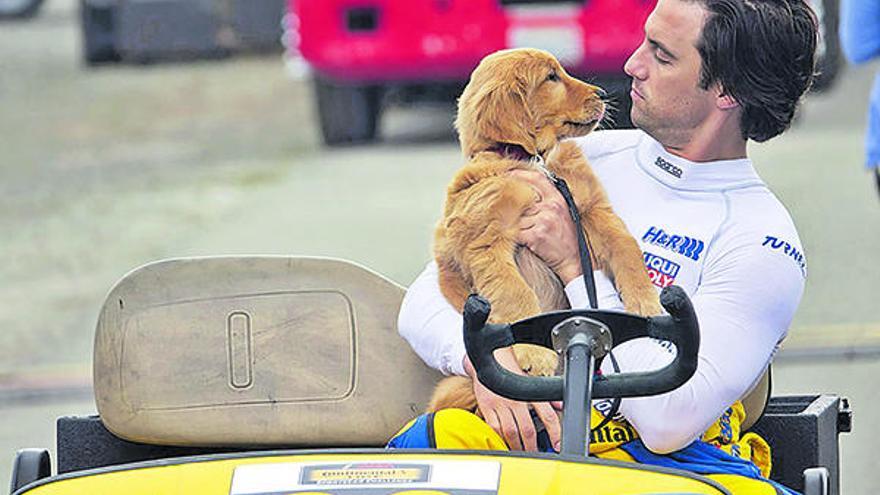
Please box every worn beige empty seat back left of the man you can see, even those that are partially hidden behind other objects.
[94,257,440,447]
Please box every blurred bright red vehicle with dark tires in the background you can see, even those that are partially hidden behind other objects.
[284,0,837,146]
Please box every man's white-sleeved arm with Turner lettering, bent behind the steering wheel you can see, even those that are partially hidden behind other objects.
[614,236,804,453]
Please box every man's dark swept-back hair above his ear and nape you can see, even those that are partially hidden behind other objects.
[697,0,818,142]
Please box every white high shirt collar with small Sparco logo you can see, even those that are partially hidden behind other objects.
[637,134,763,191]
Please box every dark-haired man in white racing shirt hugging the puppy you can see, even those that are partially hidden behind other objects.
[399,0,817,468]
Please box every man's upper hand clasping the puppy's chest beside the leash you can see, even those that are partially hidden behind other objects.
[510,170,582,284]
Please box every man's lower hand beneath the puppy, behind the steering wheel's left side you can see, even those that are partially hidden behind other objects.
[464,347,562,452]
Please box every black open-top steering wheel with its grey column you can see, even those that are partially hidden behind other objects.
[464,286,700,455]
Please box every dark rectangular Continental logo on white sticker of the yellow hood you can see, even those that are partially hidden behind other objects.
[301,463,430,485]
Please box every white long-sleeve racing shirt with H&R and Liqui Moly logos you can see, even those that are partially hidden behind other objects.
[398,130,806,453]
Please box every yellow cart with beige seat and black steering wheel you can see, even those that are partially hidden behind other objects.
[11,257,851,495]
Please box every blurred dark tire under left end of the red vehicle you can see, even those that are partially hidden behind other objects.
[314,76,382,146]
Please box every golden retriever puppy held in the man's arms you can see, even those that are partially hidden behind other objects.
[428,49,661,411]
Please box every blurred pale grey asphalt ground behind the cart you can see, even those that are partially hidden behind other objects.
[0,0,880,494]
